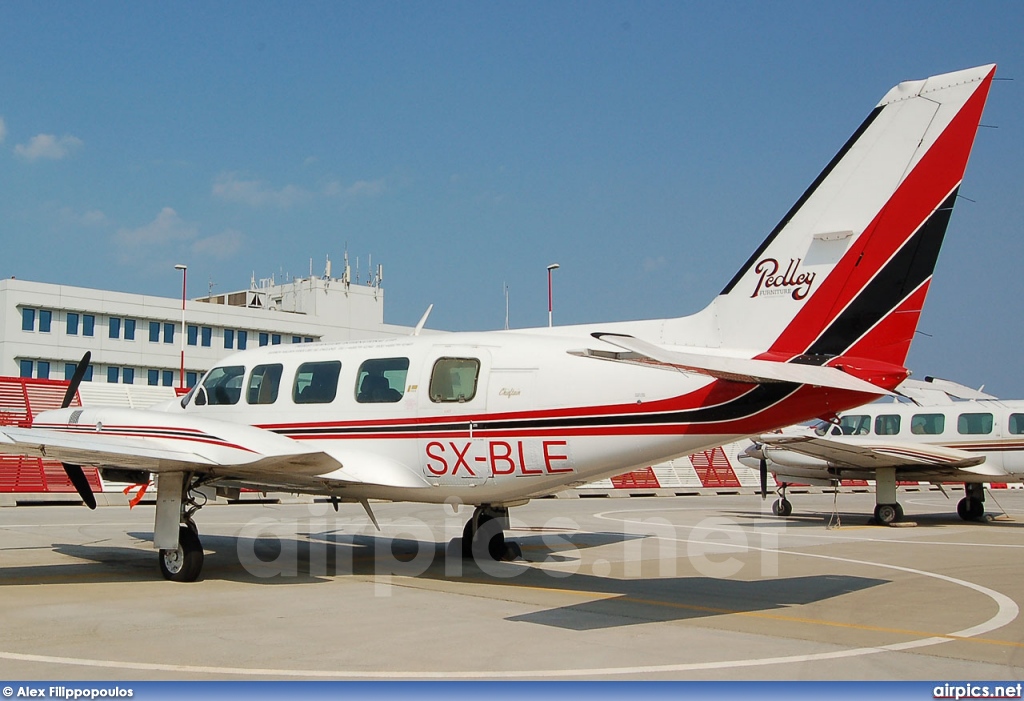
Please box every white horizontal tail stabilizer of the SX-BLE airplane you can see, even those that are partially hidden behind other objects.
[580,334,892,395]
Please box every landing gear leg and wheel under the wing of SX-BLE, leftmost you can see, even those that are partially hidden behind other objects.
[153,472,206,581]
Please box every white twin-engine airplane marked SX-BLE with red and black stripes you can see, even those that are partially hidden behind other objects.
[0,65,995,581]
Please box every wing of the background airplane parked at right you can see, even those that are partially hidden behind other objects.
[758,434,983,474]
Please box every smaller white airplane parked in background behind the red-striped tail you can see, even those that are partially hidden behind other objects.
[739,378,1024,524]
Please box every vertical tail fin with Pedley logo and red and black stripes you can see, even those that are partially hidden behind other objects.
[706,65,995,367]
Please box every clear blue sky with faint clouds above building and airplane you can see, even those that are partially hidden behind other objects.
[0,0,1024,398]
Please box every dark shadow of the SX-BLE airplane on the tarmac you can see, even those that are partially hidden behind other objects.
[0,531,889,630]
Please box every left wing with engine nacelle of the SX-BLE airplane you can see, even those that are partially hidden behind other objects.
[0,408,429,491]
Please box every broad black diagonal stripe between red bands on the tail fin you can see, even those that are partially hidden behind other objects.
[807,188,958,357]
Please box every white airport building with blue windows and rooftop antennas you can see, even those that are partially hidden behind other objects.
[0,276,412,388]
